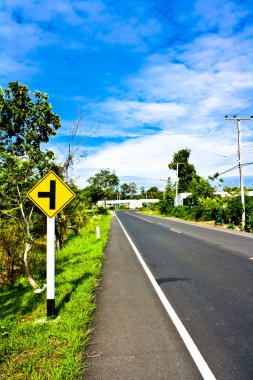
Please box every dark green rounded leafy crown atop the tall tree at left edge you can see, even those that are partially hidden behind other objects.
[0,82,60,160]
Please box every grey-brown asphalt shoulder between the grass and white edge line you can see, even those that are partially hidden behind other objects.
[85,212,202,380]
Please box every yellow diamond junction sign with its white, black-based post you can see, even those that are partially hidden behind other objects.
[27,171,75,318]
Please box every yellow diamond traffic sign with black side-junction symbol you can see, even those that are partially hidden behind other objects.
[27,171,75,218]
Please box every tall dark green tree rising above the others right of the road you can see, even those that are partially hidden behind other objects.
[168,149,198,193]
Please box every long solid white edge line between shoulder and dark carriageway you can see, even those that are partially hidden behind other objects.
[116,215,216,380]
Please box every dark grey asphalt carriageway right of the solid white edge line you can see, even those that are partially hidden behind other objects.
[117,212,253,380]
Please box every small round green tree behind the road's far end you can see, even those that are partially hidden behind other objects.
[87,169,119,199]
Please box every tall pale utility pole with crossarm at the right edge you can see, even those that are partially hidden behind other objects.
[225,115,253,229]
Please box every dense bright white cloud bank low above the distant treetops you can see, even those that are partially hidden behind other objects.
[76,132,241,187]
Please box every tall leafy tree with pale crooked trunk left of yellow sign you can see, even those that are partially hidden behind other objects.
[0,82,60,288]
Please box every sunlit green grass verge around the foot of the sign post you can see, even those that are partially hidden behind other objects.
[0,215,110,380]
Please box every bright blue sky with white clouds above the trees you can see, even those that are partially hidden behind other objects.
[0,0,253,188]
